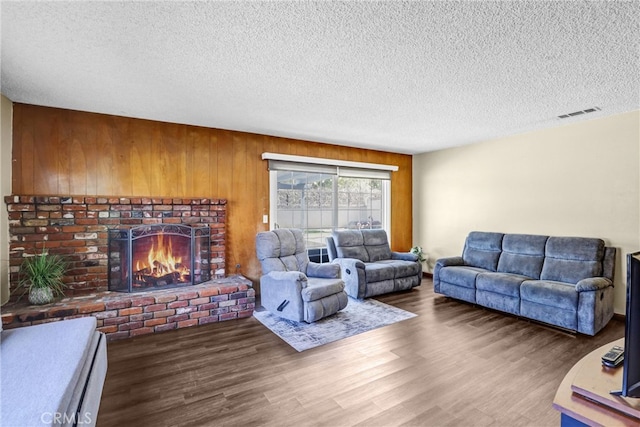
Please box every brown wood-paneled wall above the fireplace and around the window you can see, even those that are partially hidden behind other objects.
[12,104,412,288]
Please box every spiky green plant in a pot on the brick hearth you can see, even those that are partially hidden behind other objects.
[19,249,67,304]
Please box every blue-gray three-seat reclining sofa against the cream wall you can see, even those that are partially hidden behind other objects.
[433,231,616,335]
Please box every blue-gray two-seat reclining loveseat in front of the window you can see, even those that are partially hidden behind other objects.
[327,229,422,299]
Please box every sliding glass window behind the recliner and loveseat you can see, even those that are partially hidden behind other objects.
[263,153,391,262]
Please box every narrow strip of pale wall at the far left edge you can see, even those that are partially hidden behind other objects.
[0,95,13,304]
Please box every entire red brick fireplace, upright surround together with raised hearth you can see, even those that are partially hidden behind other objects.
[2,195,255,339]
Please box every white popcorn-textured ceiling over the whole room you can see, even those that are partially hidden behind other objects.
[0,0,640,153]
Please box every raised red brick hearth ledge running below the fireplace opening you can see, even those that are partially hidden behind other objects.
[2,276,255,341]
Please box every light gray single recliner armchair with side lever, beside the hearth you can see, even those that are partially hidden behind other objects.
[256,228,348,323]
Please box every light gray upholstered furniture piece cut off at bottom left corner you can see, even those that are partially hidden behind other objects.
[0,317,107,426]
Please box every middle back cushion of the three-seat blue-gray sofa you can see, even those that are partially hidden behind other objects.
[498,234,549,279]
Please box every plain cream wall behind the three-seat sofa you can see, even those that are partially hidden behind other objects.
[413,111,640,313]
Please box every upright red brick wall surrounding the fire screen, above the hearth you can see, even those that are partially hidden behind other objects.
[5,196,227,299]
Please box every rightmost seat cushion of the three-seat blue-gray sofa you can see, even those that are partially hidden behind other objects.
[520,280,579,311]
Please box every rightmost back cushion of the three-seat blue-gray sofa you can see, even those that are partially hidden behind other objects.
[540,237,604,283]
